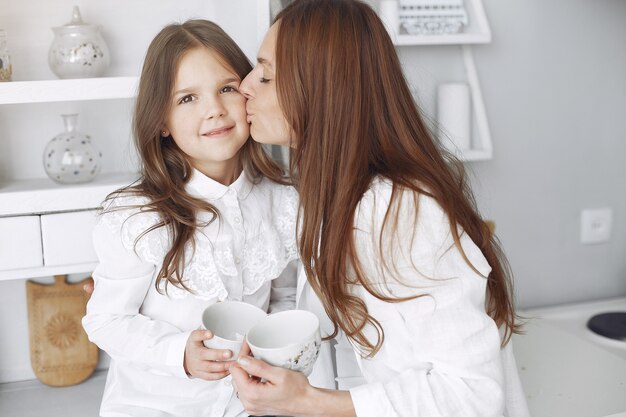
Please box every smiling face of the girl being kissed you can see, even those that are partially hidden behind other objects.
[163,47,250,184]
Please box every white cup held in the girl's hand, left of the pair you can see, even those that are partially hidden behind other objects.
[202,301,267,359]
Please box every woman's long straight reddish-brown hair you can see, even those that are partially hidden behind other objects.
[276,0,518,355]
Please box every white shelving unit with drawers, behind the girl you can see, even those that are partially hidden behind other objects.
[0,0,260,281]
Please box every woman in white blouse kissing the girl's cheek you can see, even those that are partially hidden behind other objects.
[231,0,528,417]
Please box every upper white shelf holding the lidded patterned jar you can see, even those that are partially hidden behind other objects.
[0,77,137,104]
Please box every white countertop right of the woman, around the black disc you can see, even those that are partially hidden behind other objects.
[513,298,626,417]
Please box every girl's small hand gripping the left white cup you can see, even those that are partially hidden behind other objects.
[184,330,233,381]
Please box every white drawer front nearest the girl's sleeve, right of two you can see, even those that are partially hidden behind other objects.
[41,210,98,266]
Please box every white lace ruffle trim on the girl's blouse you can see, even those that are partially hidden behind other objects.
[100,181,298,301]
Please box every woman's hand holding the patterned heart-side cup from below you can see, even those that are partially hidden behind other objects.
[230,354,315,416]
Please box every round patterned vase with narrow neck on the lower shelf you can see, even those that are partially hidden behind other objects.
[43,114,102,184]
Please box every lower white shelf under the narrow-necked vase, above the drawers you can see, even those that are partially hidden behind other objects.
[0,173,138,216]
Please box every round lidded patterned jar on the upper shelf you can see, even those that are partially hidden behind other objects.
[48,6,109,78]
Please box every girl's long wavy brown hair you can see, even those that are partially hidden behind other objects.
[107,19,284,291]
